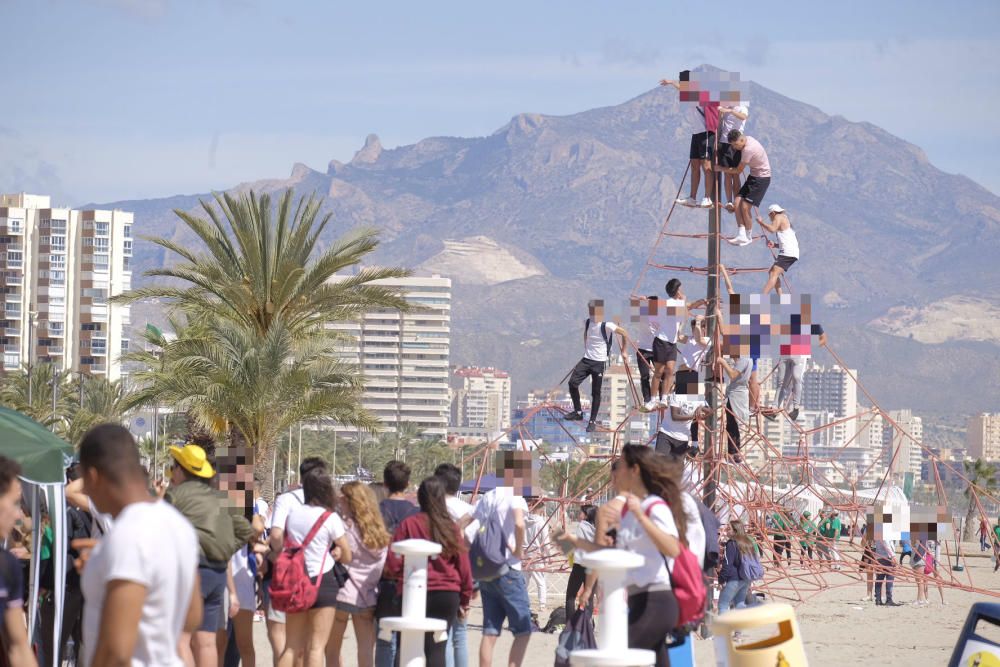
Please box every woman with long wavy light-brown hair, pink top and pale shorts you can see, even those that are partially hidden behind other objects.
[326,482,390,667]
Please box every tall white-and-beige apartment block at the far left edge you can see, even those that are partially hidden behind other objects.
[0,193,132,380]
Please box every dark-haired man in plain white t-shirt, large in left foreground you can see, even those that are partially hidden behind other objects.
[80,424,202,667]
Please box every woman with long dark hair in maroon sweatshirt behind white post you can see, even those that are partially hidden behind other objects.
[383,476,472,667]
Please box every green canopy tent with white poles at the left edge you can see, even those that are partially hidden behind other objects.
[0,407,73,667]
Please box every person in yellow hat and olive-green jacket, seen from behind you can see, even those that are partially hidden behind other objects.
[164,443,257,667]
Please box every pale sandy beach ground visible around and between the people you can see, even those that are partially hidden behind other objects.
[248,543,1000,667]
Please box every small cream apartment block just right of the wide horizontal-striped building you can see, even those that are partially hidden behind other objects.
[451,366,511,433]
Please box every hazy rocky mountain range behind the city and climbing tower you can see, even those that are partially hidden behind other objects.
[90,69,1000,422]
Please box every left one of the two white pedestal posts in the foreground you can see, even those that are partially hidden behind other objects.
[378,540,448,667]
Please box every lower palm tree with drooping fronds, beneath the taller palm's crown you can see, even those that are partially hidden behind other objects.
[128,320,378,494]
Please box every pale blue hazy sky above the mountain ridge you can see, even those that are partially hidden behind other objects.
[0,0,1000,205]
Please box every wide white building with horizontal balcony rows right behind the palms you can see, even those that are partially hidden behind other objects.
[329,276,451,438]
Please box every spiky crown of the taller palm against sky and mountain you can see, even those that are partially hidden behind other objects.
[113,189,409,339]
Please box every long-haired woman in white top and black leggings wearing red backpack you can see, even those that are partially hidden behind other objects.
[559,445,687,666]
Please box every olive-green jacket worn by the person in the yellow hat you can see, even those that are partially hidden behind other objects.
[164,480,254,567]
